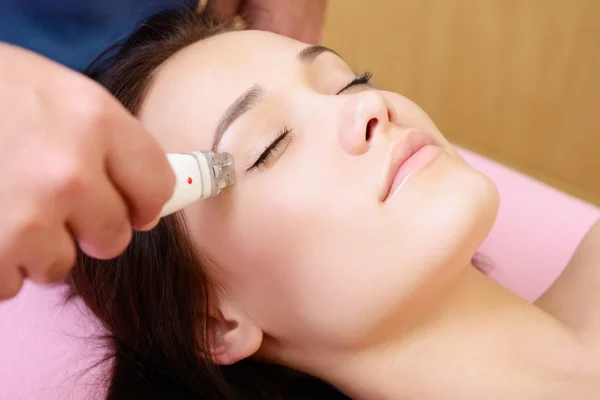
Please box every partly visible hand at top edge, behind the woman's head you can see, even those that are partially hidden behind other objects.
[207,0,327,44]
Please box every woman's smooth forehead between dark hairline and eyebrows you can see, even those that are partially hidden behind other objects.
[140,31,306,152]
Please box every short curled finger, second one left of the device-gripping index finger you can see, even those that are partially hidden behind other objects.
[25,227,76,283]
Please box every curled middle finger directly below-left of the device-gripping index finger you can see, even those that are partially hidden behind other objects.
[67,176,132,259]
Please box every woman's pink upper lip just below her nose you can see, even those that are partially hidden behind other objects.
[381,130,438,201]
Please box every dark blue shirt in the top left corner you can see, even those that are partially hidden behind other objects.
[0,0,196,71]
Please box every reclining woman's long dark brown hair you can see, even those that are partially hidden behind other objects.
[69,6,347,400]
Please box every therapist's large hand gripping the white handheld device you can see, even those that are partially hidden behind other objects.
[0,43,175,299]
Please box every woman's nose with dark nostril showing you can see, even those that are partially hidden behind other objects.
[337,90,391,156]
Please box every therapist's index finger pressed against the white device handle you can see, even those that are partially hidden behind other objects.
[106,112,175,229]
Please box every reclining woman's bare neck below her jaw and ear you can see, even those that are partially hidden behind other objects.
[276,268,597,400]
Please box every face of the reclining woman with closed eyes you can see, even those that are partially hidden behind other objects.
[140,31,498,352]
